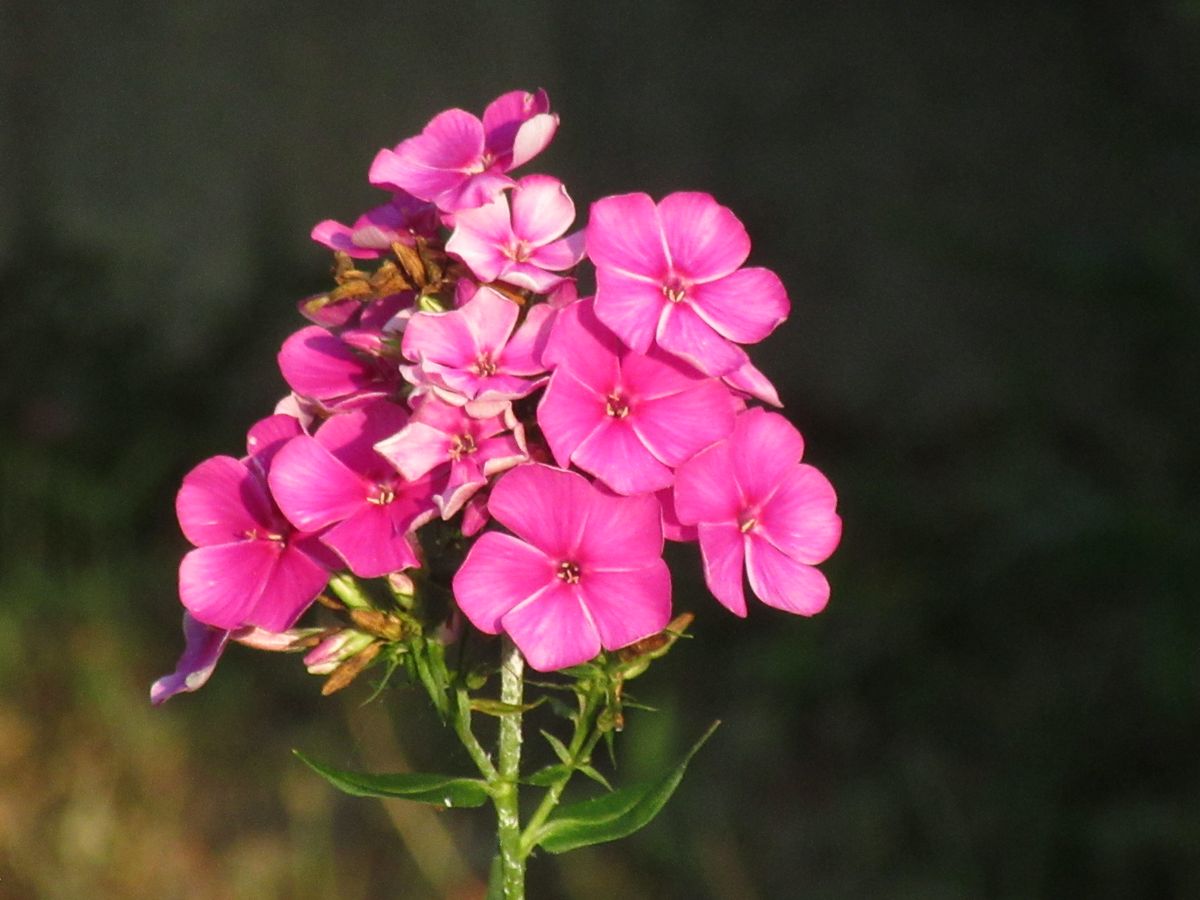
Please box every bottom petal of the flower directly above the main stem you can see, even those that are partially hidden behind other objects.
[500,578,600,672]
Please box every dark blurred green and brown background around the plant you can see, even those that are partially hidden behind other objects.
[0,0,1200,900]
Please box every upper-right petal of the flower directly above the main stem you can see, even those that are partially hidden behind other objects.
[576,491,662,571]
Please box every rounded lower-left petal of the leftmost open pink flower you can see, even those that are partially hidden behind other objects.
[179,540,283,630]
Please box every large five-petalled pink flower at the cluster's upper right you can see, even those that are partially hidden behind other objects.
[587,192,791,376]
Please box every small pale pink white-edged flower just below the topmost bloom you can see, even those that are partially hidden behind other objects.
[446,175,583,294]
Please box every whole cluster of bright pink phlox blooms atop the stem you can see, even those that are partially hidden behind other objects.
[152,91,841,702]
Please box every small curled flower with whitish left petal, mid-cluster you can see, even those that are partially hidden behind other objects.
[374,395,529,518]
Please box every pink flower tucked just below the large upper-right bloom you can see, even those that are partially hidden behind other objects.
[538,300,734,494]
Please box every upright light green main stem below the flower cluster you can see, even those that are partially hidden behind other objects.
[493,636,524,900]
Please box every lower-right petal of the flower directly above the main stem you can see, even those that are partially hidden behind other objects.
[580,559,671,650]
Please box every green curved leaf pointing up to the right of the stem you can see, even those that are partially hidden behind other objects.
[534,721,720,853]
